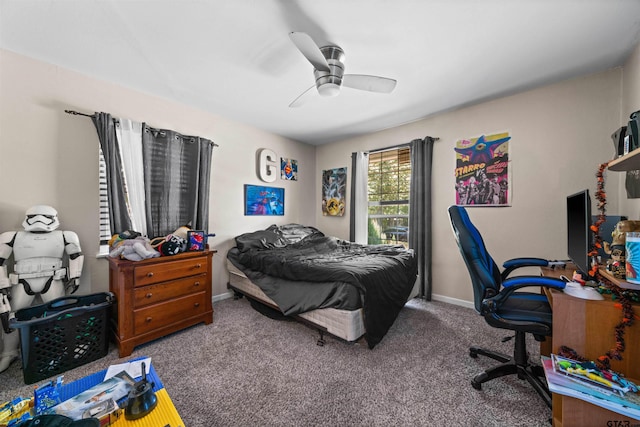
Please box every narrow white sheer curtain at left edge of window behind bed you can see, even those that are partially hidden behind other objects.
[350,151,369,245]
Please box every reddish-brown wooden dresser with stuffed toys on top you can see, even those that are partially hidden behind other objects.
[109,249,216,357]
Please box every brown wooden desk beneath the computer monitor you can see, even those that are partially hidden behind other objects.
[541,266,640,427]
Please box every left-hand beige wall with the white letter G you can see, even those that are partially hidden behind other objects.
[0,50,316,295]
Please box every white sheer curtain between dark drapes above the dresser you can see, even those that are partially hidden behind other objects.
[116,117,147,236]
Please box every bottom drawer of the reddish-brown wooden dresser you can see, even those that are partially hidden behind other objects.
[133,292,206,334]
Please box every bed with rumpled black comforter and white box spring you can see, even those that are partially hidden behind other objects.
[227,224,417,348]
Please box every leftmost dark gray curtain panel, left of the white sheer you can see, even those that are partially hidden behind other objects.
[91,113,131,234]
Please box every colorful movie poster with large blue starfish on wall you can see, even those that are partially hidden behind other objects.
[454,132,511,206]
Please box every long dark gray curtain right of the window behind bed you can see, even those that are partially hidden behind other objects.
[409,136,435,301]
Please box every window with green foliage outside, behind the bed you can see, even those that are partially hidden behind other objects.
[368,147,411,247]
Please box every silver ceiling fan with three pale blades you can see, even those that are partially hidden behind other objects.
[289,32,396,108]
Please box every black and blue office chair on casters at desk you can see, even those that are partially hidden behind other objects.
[448,206,565,408]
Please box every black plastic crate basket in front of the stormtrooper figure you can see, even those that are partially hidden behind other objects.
[10,292,115,384]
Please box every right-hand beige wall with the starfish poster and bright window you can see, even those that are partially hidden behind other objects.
[316,68,637,302]
